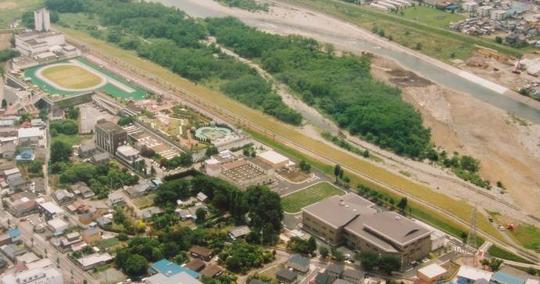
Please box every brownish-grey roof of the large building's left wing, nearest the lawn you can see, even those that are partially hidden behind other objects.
[303,193,377,228]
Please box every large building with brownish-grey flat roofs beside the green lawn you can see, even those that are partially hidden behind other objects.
[302,193,431,268]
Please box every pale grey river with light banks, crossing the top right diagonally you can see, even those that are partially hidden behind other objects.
[156,0,540,124]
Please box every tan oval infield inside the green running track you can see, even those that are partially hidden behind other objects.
[41,64,103,90]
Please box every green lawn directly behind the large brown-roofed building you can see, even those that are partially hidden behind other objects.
[281,182,345,213]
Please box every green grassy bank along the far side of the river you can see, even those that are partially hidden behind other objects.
[282,0,526,62]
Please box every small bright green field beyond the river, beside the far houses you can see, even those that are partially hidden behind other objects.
[399,6,465,28]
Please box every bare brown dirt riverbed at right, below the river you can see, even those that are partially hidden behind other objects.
[372,55,540,216]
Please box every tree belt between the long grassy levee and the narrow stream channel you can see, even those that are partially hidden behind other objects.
[46,0,302,125]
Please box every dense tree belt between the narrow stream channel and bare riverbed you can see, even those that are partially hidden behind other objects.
[207,18,430,157]
